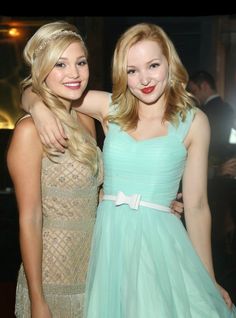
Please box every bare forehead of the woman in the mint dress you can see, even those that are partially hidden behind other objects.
[128,40,163,60]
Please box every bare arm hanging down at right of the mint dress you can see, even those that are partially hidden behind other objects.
[183,110,232,307]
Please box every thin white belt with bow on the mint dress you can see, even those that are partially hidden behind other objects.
[102,191,171,212]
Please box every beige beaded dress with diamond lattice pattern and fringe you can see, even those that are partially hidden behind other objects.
[15,148,103,318]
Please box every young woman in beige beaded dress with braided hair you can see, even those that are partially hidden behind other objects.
[7,22,102,318]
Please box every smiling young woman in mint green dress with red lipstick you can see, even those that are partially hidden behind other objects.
[23,23,236,318]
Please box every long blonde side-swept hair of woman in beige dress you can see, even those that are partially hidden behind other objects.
[21,21,98,174]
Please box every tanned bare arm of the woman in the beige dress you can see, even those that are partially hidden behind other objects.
[7,118,51,317]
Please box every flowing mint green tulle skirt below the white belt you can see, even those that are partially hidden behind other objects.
[84,201,236,318]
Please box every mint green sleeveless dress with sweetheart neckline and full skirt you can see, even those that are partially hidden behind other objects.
[84,107,236,318]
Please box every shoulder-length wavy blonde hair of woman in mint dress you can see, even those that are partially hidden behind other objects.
[107,23,195,130]
